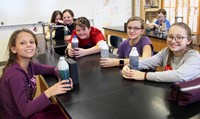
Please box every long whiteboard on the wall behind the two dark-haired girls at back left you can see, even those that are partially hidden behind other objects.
[0,0,98,26]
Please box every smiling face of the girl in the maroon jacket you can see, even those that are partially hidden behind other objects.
[11,32,36,60]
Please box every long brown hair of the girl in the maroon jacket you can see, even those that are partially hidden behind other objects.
[2,29,38,74]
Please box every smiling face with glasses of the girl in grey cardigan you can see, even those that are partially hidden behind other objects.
[167,25,191,56]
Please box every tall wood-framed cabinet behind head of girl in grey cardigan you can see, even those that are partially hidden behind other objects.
[162,0,200,34]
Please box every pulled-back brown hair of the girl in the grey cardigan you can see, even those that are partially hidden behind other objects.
[167,22,193,65]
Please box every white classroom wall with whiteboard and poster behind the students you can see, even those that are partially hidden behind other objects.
[0,0,132,63]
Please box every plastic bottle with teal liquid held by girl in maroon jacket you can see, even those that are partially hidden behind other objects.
[57,57,70,84]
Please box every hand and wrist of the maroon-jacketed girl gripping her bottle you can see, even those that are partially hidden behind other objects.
[44,78,73,98]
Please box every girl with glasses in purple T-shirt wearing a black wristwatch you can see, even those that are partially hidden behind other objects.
[100,17,153,67]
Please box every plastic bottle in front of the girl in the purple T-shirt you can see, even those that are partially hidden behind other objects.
[99,41,109,58]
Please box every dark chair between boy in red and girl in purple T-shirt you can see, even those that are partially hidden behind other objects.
[109,36,122,53]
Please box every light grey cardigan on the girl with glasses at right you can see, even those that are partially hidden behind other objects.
[139,48,200,82]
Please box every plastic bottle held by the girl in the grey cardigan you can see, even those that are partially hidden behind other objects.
[129,47,139,70]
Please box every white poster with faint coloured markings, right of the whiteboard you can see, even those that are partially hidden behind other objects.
[94,0,132,27]
